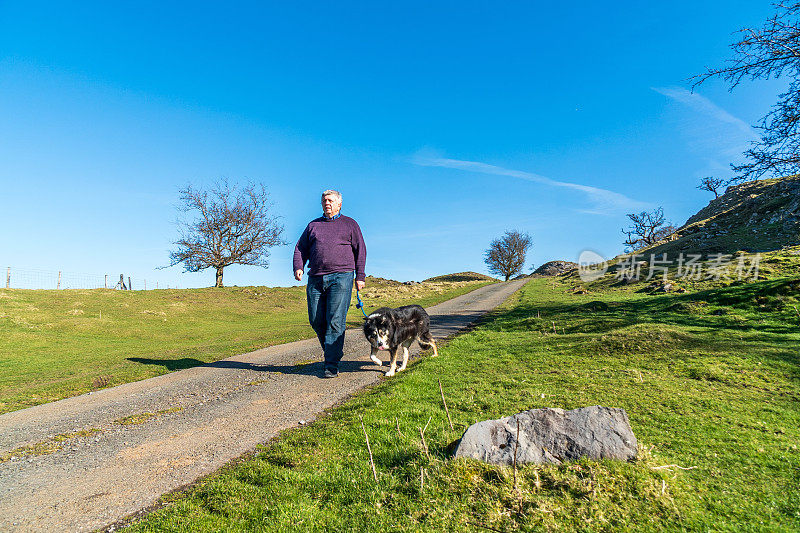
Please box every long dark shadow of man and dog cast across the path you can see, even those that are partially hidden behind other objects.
[127,357,389,376]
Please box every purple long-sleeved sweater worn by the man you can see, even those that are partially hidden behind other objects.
[293,215,367,281]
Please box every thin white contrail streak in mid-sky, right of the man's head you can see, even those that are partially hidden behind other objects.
[413,154,651,215]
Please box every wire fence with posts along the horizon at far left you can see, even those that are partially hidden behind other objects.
[0,267,176,290]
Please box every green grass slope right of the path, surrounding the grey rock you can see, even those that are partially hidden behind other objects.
[122,262,800,531]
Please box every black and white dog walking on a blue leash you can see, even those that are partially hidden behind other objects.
[364,305,439,376]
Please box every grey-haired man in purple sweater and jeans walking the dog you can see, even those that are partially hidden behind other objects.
[294,190,367,378]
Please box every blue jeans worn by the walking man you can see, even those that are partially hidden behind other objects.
[306,272,355,372]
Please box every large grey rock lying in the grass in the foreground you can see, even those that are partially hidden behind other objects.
[455,405,637,465]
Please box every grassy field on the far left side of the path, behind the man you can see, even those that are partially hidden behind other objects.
[0,278,488,413]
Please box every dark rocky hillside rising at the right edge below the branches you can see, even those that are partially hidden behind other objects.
[642,175,800,255]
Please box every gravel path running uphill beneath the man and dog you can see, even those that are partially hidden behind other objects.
[0,280,527,531]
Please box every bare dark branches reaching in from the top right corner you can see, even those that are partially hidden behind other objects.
[692,2,800,183]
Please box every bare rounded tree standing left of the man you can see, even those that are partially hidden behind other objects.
[169,179,286,287]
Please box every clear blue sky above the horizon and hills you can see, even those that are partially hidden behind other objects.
[0,1,783,287]
